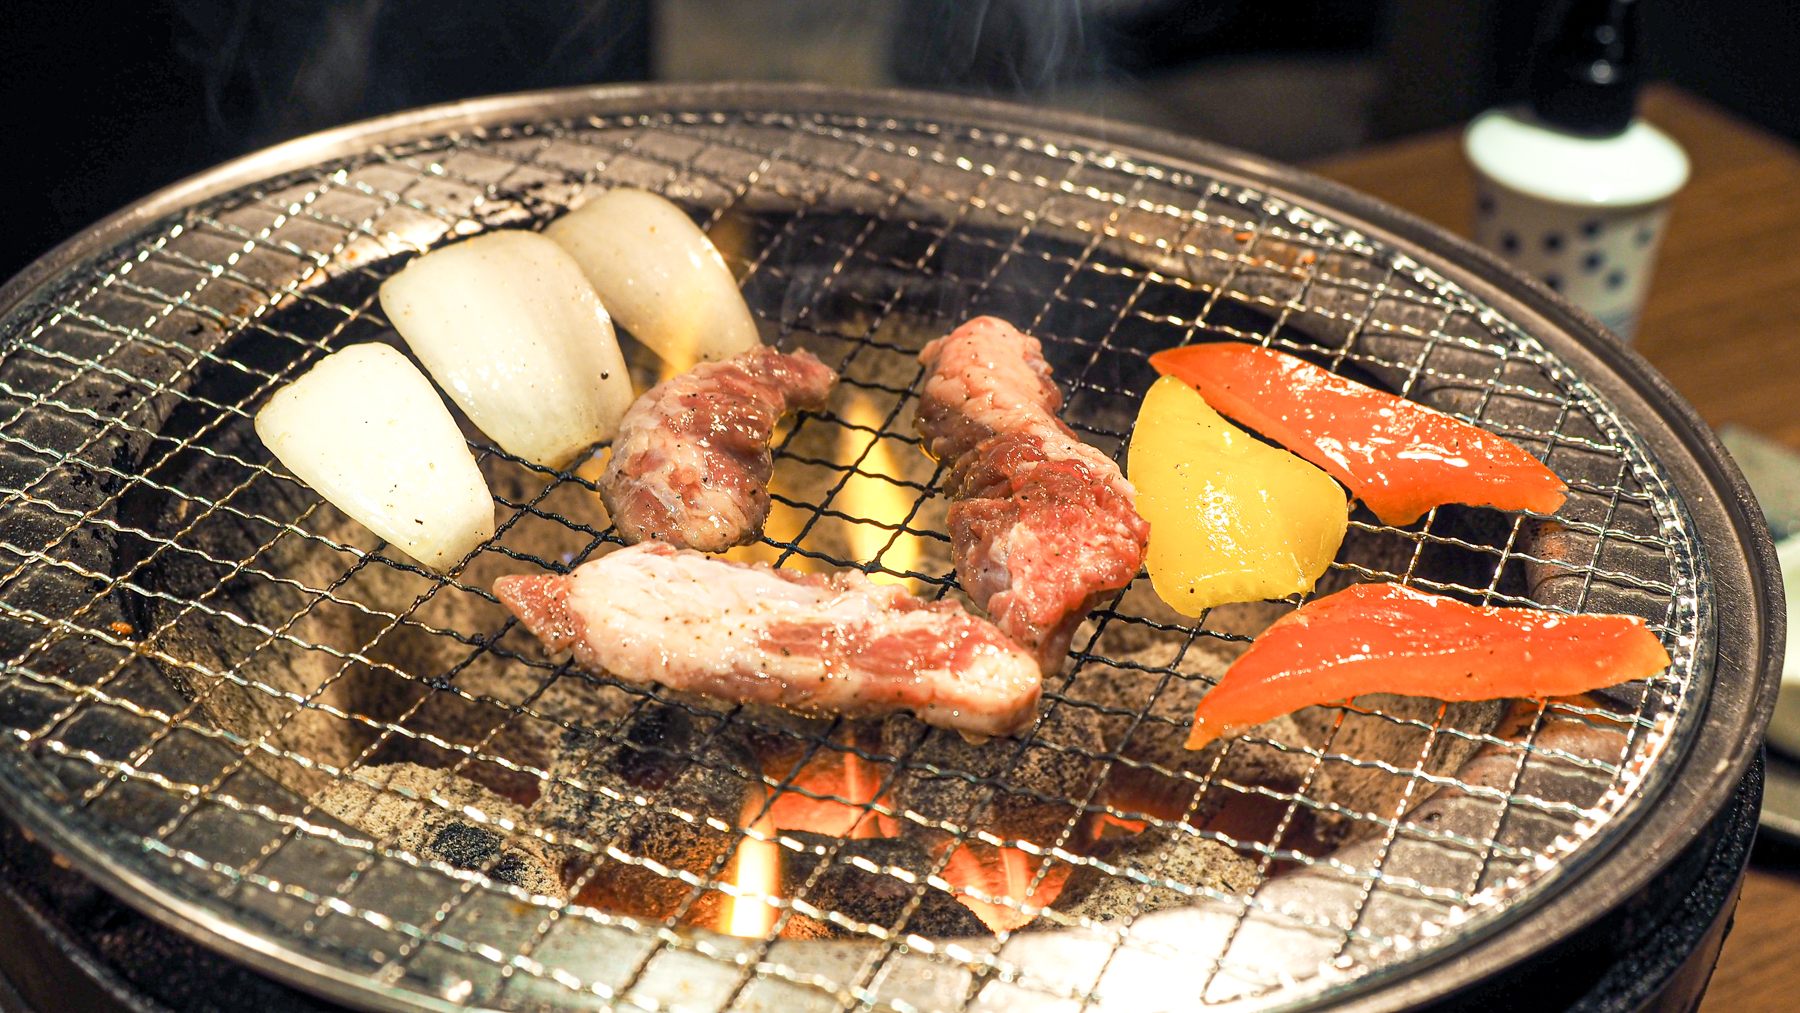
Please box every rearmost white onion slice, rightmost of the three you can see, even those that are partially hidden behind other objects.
[544,189,761,371]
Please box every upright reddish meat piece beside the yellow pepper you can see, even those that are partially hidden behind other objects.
[918,317,1150,671]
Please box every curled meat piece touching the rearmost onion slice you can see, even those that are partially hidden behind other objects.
[599,347,837,552]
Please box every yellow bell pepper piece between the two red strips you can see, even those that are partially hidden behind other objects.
[1127,376,1350,615]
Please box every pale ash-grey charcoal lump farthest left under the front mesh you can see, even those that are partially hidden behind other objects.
[313,763,563,900]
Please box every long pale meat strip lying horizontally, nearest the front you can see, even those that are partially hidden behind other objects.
[493,542,1039,736]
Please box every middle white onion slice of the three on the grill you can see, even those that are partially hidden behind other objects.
[382,232,632,468]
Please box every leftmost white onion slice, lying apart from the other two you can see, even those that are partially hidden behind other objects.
[256,344,493,570]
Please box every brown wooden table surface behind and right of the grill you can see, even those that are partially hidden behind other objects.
[1310,86,1800,1013]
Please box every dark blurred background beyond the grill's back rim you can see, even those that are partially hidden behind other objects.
[0,0,1800,277]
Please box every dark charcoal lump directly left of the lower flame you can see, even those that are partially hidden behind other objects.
[527,702,758,918]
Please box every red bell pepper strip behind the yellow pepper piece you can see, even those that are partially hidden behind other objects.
[1150,342,1568,524]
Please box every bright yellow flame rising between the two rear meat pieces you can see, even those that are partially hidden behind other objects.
[832,392,920,590]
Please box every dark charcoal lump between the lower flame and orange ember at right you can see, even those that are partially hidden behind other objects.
[781,833,986,939]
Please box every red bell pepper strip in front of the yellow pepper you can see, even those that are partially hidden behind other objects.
[1188,583,1669,749]
